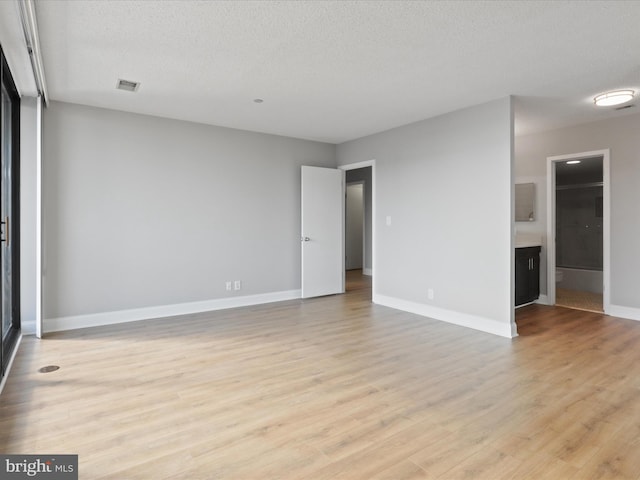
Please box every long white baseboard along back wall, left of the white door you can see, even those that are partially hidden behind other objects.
[46,290,301,332]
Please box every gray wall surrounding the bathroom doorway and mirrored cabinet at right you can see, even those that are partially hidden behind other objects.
[515,114,640,318]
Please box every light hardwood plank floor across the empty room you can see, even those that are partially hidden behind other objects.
[0,272,640,480]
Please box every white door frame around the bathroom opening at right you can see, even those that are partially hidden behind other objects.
[547,148,611,313]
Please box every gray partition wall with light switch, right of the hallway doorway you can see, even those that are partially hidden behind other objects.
[337,98,515,335]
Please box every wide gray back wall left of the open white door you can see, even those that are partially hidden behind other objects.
[43,102,336,318]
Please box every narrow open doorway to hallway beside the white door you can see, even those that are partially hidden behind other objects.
[341,162,374,294]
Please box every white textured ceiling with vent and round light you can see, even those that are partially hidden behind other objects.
[31,0,640,143]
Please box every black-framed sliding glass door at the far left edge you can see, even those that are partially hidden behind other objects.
[0,47,20,382]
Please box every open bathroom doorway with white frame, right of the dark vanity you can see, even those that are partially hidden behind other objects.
[547,151,609,312]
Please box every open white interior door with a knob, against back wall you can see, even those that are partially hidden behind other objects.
[301,166,344,298]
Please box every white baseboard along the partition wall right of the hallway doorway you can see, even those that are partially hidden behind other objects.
[373,294,518,338]
